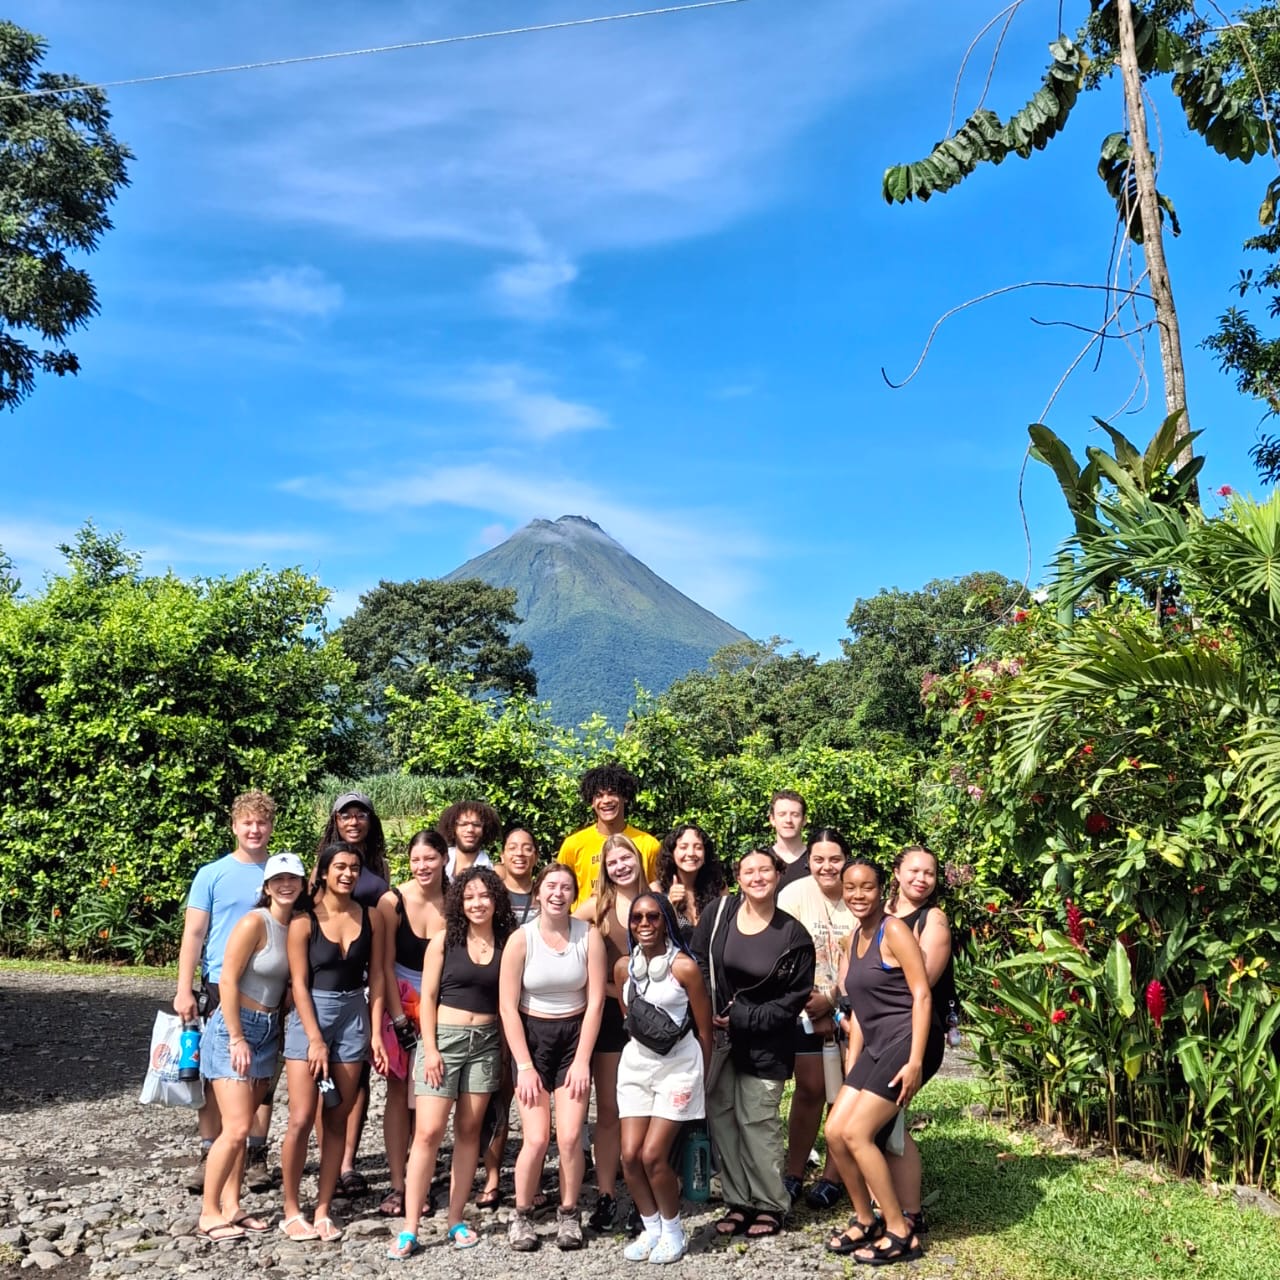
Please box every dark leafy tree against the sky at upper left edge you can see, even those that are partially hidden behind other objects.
[0,22,132,408]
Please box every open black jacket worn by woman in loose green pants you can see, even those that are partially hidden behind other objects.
[691,895,814,1080]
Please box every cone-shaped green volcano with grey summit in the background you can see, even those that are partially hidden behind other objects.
[444,516,745,724]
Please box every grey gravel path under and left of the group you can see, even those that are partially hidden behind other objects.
[0,972,952,1280]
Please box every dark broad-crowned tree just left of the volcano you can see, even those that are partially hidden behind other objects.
[338,577,538,737]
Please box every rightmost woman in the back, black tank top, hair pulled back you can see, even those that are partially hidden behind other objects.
[886,845,960,1231]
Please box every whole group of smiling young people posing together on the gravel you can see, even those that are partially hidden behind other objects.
[174,764,954,1263]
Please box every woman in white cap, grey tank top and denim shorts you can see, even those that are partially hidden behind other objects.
[198,854,306,1240]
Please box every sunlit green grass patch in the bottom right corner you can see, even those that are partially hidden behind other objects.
[916,1080,1280,1280]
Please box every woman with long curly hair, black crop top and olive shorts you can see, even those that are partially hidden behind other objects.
[387,867,516,1258]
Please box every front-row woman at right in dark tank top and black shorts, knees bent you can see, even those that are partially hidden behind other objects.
[827,858,937,1265]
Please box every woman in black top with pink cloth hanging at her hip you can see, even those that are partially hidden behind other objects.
[378,831,448,1217]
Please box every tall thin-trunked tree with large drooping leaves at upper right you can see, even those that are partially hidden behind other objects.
[883,0,1271,481]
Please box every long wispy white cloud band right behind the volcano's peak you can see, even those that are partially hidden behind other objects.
[280,462,769,621]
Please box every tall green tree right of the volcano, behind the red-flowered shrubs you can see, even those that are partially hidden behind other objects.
[841,573,1027,744]
